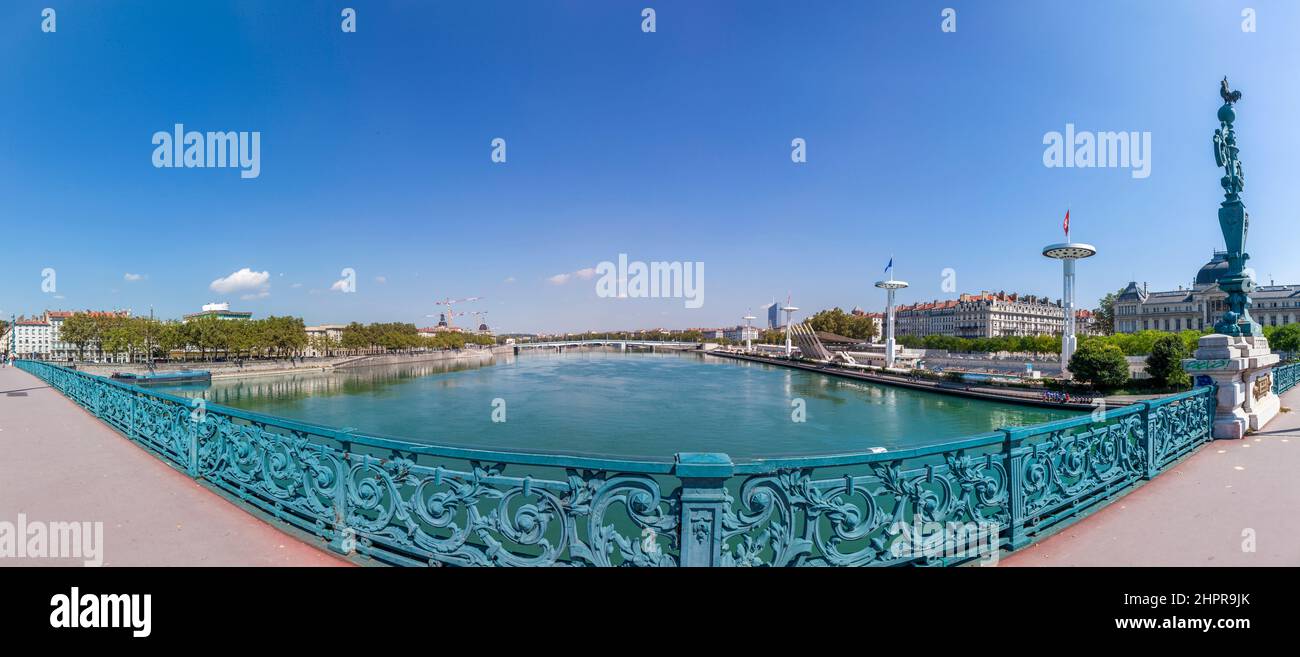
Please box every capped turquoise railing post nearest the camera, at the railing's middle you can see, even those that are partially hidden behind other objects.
[673,451,736,567]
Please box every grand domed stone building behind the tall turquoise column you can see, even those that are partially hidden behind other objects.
[1114,251,1300,333]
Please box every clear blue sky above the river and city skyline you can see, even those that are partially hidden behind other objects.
[0,0,1300,332]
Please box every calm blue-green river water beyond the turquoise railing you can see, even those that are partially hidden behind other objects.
[164,351,1074,459]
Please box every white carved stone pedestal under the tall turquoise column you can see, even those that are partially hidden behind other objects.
[1183,333,1281,438]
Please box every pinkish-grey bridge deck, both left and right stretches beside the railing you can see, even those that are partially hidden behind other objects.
[0,359,1300,566]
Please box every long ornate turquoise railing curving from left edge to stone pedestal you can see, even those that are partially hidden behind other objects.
[18,360,1214,566]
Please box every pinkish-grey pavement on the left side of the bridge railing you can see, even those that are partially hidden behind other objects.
[0,367,347,566]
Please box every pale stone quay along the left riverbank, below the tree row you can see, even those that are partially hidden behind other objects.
[65,346,514,379]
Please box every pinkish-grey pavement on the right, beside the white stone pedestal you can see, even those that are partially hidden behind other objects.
[1001,388,1300,566]
